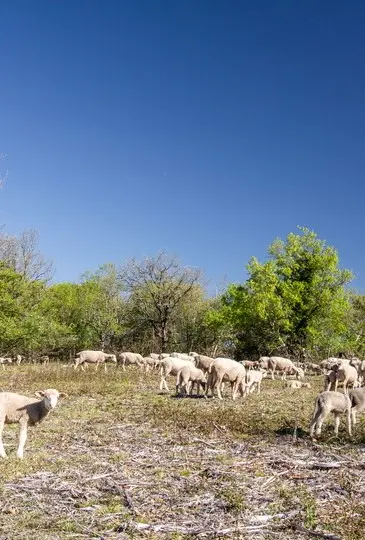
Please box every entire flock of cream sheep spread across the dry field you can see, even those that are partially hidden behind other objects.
[0,350,365,458]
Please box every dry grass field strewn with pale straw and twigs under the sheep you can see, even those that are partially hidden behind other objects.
[0,365,365,540]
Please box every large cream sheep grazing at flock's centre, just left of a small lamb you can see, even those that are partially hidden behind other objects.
[205,358,246,400]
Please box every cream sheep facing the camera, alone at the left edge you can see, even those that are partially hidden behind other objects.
[0,388,67,459]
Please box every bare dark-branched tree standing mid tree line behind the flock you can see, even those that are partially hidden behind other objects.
[119,252,201,352]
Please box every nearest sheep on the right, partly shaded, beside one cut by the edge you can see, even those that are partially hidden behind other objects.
[309,392,351,438]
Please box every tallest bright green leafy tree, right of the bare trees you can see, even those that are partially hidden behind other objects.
[222,228,352,356]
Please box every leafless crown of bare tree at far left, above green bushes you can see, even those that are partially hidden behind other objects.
[0,229,53,281]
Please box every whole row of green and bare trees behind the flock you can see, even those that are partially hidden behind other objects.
[0,228,365,360]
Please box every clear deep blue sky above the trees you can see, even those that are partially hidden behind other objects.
[0,0,365,296]
